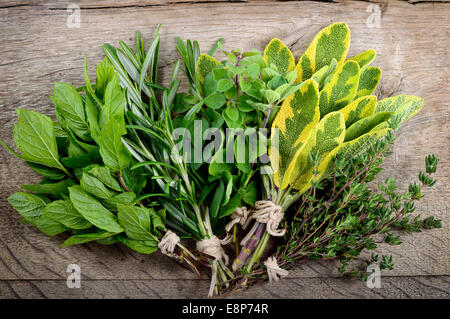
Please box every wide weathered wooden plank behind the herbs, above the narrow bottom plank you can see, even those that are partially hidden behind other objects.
[0,0,450,292]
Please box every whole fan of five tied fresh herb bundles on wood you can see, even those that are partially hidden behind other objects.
[0,23,440,296]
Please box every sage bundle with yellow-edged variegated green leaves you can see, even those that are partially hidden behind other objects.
[227,23,434,280]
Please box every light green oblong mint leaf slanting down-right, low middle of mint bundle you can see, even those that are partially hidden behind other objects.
[69,185,123,233]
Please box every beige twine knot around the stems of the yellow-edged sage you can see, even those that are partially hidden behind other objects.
[252,200,286,237]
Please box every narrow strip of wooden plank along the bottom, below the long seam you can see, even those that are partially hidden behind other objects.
[0,276,450,299]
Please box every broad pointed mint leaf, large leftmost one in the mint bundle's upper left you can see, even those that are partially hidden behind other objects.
[13,109,66,171]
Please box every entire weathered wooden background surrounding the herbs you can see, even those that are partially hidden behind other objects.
[0,0,450,298]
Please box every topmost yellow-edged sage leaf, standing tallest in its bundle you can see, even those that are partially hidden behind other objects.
[295,23,350,84]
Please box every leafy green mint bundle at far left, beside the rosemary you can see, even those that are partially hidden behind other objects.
[0,45,196,276]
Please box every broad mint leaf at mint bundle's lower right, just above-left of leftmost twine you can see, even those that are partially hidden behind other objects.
[117,204,155,240]
